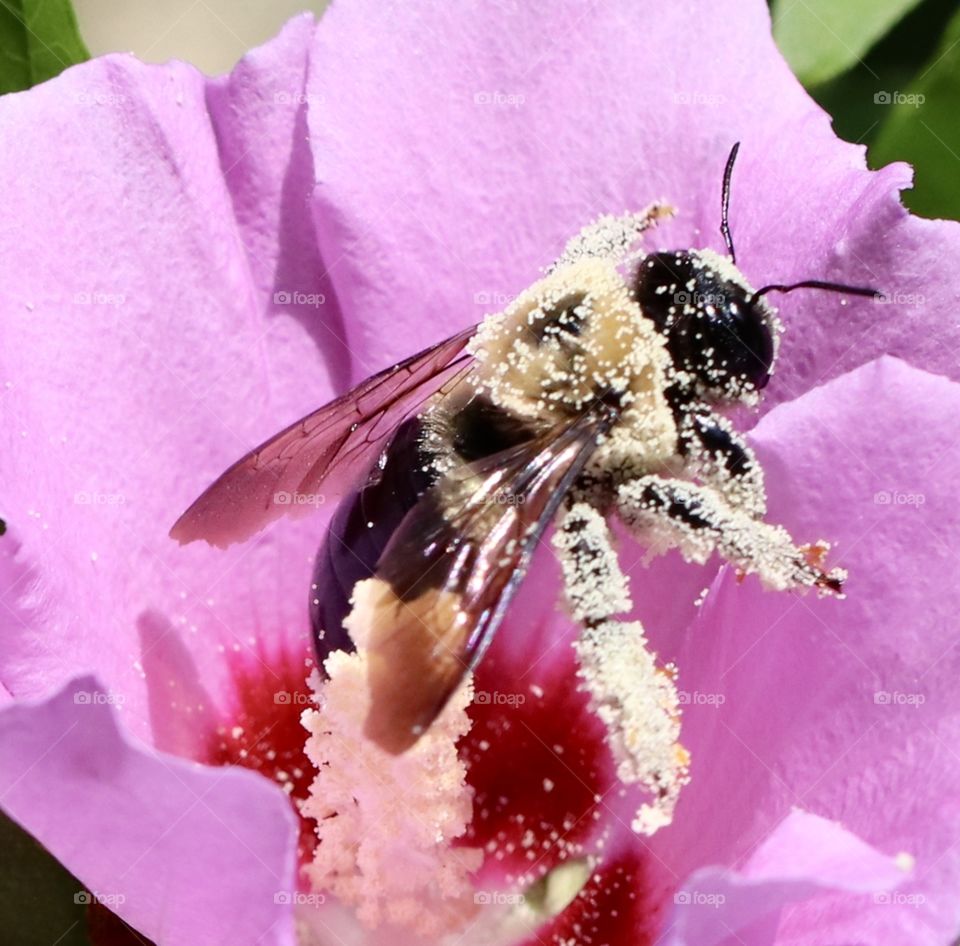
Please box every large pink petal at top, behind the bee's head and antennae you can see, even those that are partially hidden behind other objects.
[308,0,960,400]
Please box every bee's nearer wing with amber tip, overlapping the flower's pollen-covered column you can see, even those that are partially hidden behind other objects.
[356,414,609,753]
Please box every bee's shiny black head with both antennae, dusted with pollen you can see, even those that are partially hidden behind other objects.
[633,142,877,403]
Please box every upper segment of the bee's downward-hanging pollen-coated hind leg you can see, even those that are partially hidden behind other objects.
[552,502,633,627]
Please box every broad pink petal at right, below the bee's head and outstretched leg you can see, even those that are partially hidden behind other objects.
[636,358,960,946]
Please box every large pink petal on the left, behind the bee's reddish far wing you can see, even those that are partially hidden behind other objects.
[0,11,330,744]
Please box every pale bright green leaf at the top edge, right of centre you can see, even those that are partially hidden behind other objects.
[771,0,920,86]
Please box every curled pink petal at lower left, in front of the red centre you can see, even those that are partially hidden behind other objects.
[0,676,296,946]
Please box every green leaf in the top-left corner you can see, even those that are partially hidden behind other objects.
[0,0,90,93]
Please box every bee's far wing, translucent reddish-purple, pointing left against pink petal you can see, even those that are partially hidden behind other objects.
[170,328,475,546]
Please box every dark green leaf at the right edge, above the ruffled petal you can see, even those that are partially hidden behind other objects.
[870,7,960,218]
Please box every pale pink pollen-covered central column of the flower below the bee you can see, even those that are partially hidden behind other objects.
[302,651,482,937]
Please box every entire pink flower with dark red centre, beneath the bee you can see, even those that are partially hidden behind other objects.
[0,0,960,946]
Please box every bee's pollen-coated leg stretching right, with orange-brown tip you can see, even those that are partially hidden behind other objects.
[616,476,846,594]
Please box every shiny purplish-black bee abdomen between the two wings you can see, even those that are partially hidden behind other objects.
[310,417,437,665]
